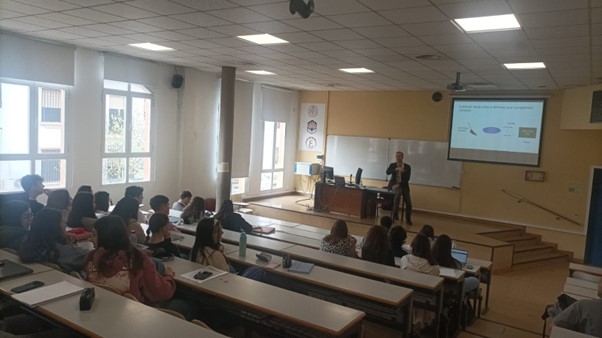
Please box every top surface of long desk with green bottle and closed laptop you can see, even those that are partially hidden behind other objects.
[226,249,412,307]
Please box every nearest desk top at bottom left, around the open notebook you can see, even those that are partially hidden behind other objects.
[0,270,224,338]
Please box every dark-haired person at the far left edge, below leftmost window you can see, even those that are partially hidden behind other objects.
[0,200,33,251]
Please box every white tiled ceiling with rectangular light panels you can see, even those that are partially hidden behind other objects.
[0,0,602,93]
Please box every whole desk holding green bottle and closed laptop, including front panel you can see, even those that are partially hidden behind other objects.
[227,249,412,337]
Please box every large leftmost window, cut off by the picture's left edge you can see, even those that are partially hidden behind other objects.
[0,80,67,192]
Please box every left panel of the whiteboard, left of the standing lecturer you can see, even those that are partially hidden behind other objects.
[326,135,389,180]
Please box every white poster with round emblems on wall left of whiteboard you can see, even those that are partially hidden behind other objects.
[299,103,326,151]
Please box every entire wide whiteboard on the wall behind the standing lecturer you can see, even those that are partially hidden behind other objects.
[326,135,462,188]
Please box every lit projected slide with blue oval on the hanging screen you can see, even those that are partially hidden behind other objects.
[450,101,543,154]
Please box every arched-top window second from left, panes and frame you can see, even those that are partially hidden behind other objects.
[102,80,153,184]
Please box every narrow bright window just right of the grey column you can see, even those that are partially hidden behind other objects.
[259,121,286,191]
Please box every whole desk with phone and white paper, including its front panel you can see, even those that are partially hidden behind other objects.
[165,258,366,337]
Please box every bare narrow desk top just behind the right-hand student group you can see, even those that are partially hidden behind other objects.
[284,245,443,291]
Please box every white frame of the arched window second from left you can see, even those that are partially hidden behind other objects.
[100,83,157,186]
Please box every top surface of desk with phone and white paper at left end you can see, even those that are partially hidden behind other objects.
[165,258,366,336]
